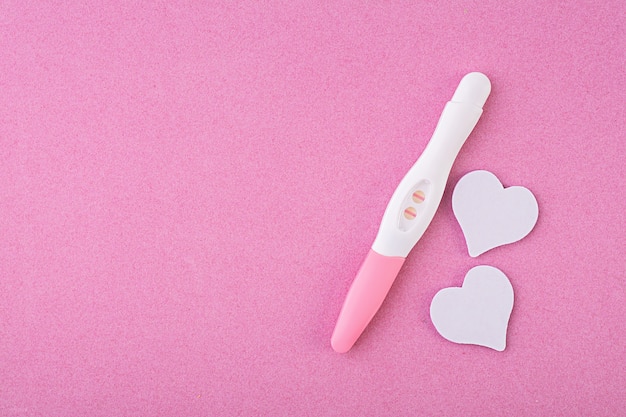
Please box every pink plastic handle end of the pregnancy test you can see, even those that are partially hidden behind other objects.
[330,250,404,353]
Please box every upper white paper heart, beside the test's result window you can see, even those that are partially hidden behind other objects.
[452,171,539,257]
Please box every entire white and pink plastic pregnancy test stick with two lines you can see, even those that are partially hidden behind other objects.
[331,72,491,353]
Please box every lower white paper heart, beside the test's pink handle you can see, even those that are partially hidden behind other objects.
[430,265,513,351]
